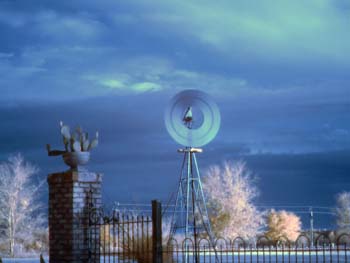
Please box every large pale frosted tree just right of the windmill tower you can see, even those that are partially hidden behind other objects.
[203,162,264,239]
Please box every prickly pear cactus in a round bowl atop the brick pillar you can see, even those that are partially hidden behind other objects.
[46,121,99,169]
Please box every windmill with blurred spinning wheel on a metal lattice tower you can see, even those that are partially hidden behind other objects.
[165,90,220,259]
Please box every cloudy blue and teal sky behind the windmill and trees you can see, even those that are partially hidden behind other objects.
[0,0,350,228]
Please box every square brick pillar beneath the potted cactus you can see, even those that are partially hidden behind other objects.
[47,170,102,263]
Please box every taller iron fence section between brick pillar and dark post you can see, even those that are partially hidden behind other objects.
[89,211,152,263]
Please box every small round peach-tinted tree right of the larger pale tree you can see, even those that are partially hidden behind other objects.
[266,210,301,242]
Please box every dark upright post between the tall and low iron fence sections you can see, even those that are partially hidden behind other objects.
[152,200,162,263]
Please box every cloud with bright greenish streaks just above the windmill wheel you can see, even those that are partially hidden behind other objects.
[82,57,249,96]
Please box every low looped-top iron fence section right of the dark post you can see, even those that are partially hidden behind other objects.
[163,235,350,263]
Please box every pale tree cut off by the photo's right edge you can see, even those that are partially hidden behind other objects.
[335,192,350,233]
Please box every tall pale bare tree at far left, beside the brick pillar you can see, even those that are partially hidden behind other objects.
[0,155,45,257]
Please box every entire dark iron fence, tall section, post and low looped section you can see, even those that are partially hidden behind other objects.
[89,201,350,263]
